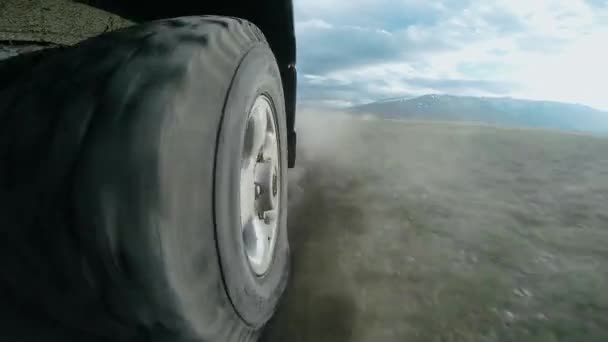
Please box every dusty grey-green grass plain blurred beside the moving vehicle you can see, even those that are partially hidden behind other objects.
[264,113,608,342]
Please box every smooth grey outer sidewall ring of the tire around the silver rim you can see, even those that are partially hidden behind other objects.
[214,44,289,328]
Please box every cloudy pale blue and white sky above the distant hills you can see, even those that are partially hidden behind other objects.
[294,0,608,110]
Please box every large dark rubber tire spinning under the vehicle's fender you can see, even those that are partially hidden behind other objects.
[0,16,289,342]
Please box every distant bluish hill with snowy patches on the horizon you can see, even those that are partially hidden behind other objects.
[350,95,608,134]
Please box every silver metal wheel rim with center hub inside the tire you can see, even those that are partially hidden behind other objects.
[240,95,281,276]
